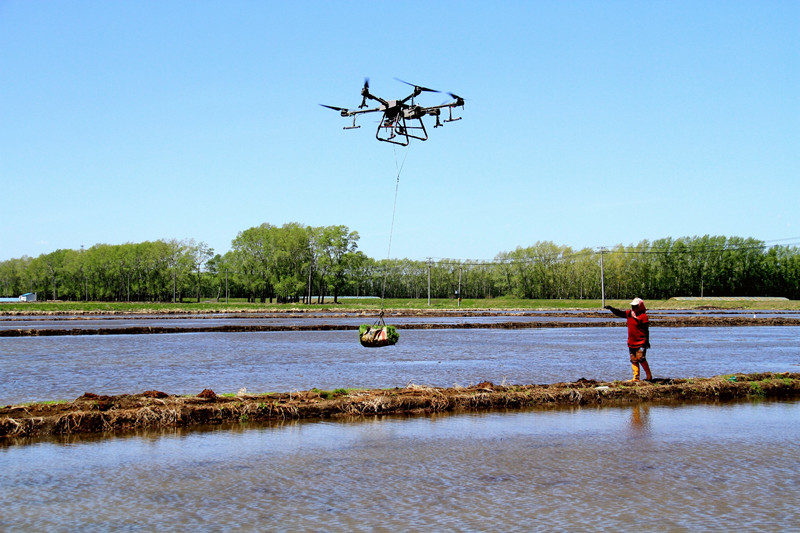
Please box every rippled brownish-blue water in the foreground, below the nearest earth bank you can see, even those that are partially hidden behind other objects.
[0,402,800,531]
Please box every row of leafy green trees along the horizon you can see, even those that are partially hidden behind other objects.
[0,223,800,303]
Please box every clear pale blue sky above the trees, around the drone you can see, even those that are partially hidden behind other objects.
[0,0,800,260]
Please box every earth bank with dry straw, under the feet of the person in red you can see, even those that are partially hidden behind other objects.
[0,373,800,438]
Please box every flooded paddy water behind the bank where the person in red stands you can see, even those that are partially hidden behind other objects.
[0,326,800,404]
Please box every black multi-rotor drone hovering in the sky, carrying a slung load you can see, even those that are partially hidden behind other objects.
[320,78,464,146]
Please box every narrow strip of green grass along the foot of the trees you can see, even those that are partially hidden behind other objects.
[0,297,800,316]
